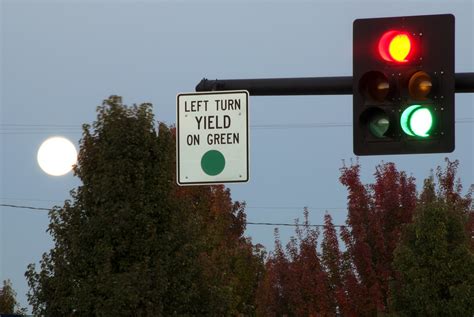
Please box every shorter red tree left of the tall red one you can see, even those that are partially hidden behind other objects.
[257,209,335,316]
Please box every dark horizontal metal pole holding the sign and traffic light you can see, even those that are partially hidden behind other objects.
[196,73,474,96]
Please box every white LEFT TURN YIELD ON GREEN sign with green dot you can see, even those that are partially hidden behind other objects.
[176,91,249,185]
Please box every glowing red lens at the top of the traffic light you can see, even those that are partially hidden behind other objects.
[378,30,413,63]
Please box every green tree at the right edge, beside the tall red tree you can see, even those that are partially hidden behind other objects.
[391,161,474,316]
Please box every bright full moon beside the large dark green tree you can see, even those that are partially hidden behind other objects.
[37,137,77,176]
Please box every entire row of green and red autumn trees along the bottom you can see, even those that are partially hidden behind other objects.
[23,96,474,317]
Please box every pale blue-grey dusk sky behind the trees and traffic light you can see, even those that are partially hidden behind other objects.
[0,0,474,306]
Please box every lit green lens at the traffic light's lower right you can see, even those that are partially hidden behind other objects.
[400,105,434,138]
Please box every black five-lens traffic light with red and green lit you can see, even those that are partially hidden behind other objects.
[353,14,454,155]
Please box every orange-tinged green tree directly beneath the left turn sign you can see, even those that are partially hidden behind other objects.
[176,185,265,316]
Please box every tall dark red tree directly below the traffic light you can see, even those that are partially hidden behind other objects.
[340,163,416,316]
